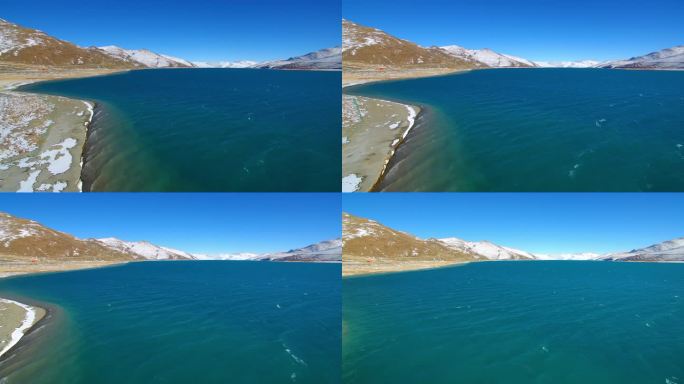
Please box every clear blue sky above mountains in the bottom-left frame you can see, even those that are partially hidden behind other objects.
[0,193,342,254]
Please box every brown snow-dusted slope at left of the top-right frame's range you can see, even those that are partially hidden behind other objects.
[342,20,484,69]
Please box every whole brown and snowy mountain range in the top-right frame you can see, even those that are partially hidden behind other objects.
[342,20,684,69]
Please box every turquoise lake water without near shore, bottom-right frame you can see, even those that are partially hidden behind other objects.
[342,261,684,384]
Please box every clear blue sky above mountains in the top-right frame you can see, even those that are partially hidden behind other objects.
[342,0,684,61]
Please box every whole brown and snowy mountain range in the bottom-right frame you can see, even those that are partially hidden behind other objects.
[342,213,684,261]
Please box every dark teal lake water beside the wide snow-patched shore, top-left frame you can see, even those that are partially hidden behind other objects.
[22,69,341,191]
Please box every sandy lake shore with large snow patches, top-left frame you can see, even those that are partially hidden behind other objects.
[0,64,125,192]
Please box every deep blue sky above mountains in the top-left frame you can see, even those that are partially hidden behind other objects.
[0,0,341,61]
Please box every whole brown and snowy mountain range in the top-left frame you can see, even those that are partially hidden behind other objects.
[0,19,342,70]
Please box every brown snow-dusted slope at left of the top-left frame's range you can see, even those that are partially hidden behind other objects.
[0,19,135,68]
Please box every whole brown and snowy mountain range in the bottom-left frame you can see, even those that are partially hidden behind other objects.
[0,212,342,262]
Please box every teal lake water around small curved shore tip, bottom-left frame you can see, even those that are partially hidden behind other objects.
[0,261,341,384]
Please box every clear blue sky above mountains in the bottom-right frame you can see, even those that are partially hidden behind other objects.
[342,193,684,254]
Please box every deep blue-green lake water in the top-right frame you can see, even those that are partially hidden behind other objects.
[347,69,684,191]
